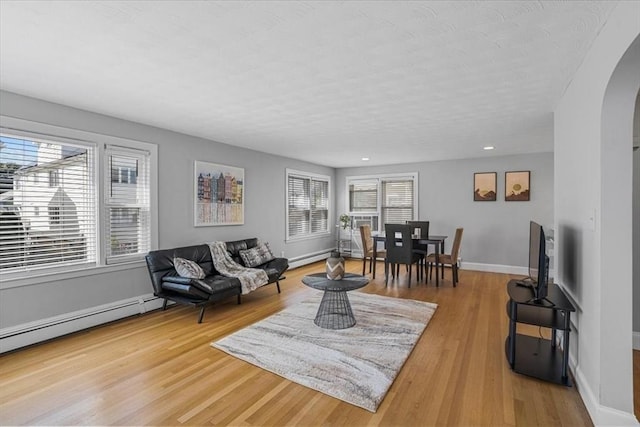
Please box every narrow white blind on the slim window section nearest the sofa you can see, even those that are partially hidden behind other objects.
[105,146,151,264]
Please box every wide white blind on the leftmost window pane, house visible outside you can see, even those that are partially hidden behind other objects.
[0,134,96,271]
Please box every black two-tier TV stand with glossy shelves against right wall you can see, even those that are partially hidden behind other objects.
[505,280,576,386]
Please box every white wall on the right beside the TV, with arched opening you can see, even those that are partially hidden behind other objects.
[554,2,640,425]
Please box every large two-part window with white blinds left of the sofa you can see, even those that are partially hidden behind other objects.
[0,124,157,279]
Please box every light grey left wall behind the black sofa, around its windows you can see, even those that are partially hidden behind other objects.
[0,92,335,347]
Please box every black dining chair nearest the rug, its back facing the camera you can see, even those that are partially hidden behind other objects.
[384,224,420,287]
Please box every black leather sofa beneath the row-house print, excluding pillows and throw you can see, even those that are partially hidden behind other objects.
[145,238,289,323]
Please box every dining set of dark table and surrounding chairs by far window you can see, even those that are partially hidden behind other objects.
[358,221,464,288]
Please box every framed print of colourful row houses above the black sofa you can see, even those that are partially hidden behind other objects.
[193,160,244,227]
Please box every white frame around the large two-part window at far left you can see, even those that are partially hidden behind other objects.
[0,116,158,289]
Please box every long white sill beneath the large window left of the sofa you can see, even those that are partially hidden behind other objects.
[0,260,145,290]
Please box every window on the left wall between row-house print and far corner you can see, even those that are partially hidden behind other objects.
[286,169,330,240]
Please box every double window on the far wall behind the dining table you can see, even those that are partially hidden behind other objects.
[347,173,418,231]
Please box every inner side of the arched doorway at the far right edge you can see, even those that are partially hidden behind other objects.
[600,33,640,422]
